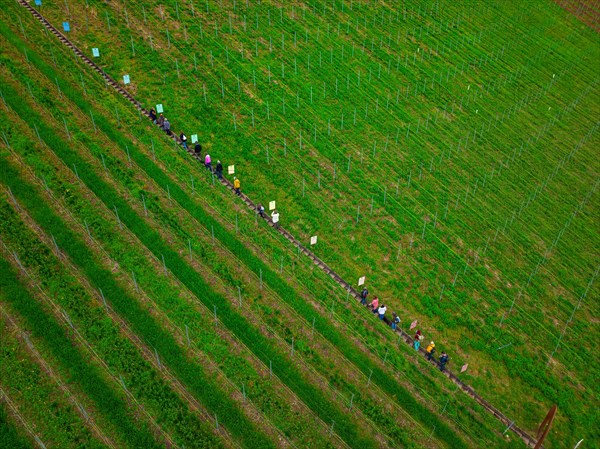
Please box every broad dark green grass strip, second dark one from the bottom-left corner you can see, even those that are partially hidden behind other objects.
[0,258,160,448]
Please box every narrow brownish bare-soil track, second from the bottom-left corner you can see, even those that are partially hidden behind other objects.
[0,302,116,448]
